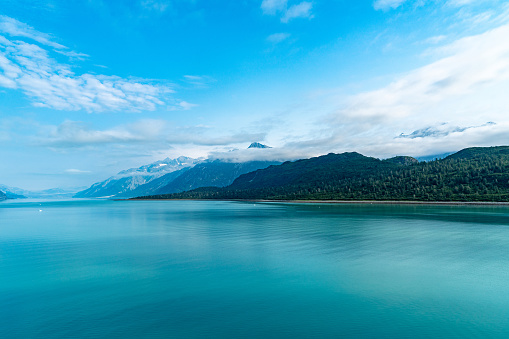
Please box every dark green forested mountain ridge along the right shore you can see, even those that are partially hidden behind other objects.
[140,146,509,201]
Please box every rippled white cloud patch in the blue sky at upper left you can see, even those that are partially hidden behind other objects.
[0,16,179,112]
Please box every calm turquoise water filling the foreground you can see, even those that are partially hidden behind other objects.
[0,201,509,338]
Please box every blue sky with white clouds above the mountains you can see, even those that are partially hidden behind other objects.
[0,0,509,190]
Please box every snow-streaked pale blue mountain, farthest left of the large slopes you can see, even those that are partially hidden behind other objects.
[74,157,202,198]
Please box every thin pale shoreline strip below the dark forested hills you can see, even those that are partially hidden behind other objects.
[122,198,509,206]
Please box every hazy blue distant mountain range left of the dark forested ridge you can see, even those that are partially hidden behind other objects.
[74,142,280,198]
